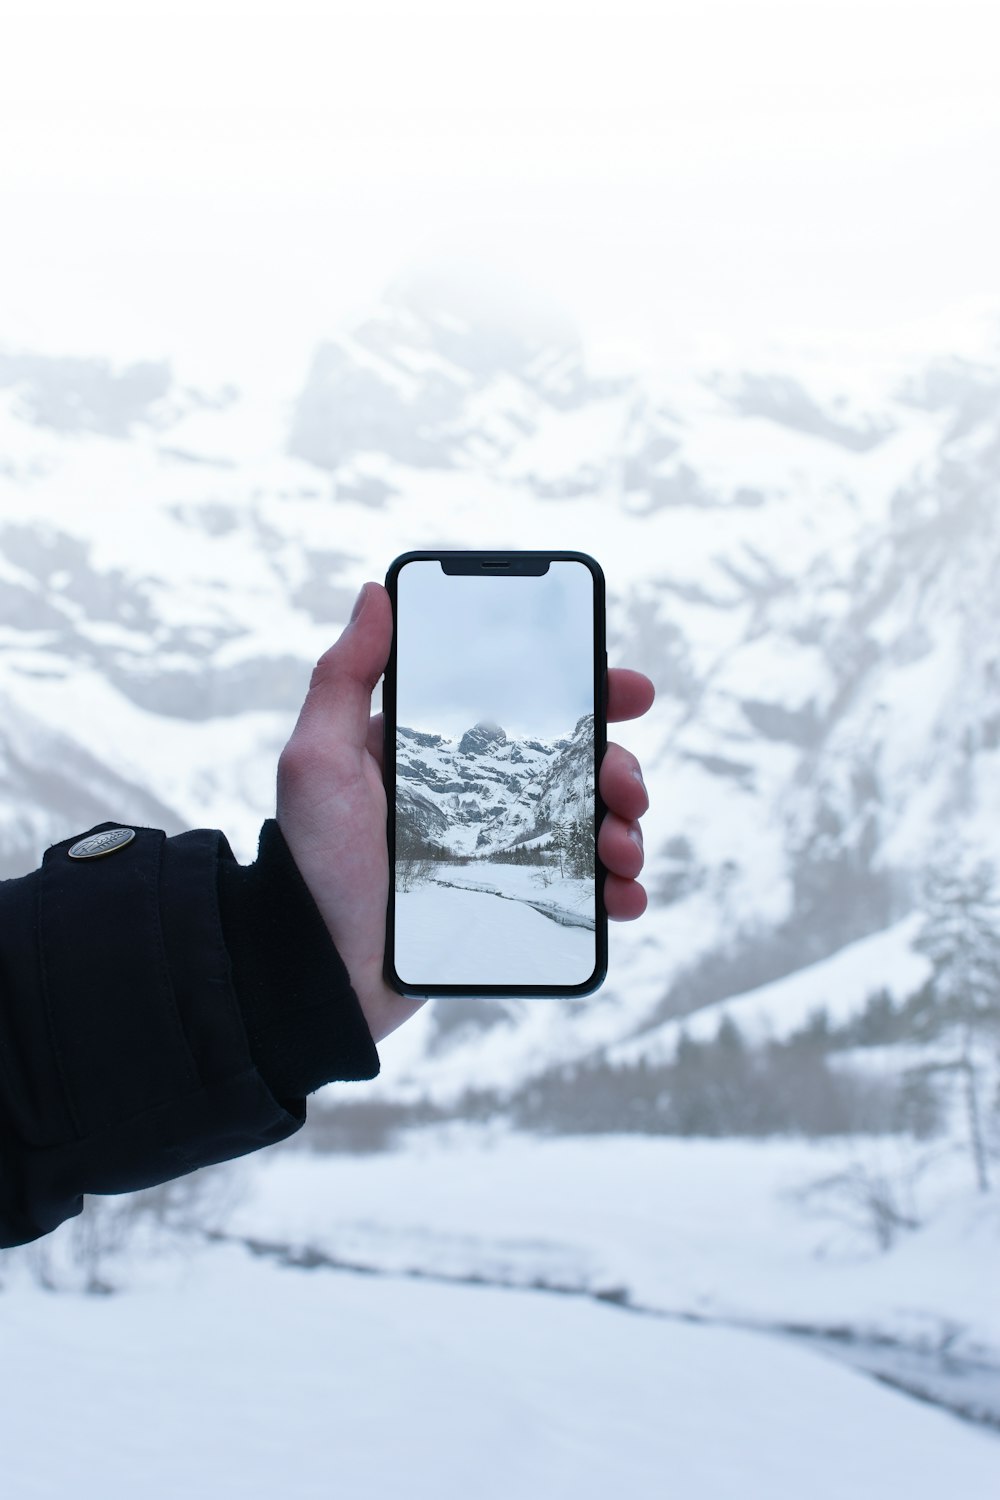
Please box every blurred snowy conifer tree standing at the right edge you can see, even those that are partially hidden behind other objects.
[916,860,1000,1193]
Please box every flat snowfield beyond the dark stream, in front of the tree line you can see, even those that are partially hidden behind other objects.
[226,1125,1000,1362]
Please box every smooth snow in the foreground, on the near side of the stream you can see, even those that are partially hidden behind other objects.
[0,1248,1000,1500]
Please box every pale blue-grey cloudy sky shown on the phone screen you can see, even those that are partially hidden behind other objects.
[396,561,594,740]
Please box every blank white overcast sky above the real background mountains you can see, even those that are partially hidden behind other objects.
[0,0,1000,374]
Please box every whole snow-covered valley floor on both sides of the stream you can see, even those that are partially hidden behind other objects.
[0,1127,1000,1500]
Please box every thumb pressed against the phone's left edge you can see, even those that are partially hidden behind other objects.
[298,584,393,750]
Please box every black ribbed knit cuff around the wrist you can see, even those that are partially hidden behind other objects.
[219,819,379,1100]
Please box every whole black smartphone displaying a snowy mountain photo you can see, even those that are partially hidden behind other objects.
[384,552,607,996]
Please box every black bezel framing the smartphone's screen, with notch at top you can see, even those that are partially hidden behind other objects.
[382,549,607,999]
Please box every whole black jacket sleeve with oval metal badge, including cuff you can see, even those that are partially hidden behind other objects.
[0,822,378,1247]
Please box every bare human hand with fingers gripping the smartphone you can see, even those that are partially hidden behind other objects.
[277,584,654,1043]
